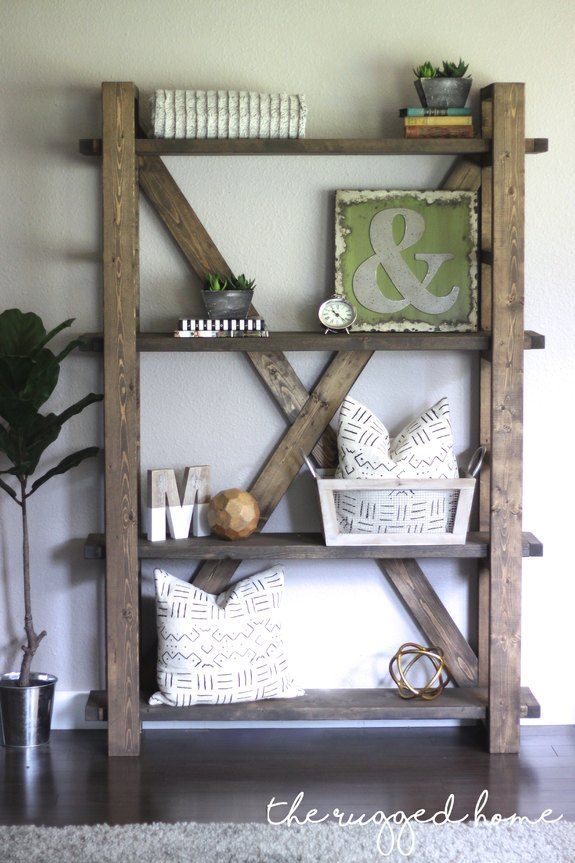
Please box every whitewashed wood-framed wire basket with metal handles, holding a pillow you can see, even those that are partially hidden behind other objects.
[306,447,485,546]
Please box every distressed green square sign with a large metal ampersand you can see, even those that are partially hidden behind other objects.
[335,191,478,332]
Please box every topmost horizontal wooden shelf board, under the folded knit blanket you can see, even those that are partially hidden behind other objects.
[79,138,548,156]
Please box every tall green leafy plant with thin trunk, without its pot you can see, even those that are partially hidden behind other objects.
[0,309,102,686]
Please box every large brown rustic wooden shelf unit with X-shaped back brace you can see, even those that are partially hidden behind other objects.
[88,82,547,755]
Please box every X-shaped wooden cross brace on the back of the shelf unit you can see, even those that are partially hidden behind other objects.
[138,150,481,686]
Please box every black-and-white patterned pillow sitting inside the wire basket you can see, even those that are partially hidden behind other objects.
[334,397,459,534]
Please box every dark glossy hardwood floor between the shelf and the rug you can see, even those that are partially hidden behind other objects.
[0,726,575,825]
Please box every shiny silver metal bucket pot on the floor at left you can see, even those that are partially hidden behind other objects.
[0,671,58,747]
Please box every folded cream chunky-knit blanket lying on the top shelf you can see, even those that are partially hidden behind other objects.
[152,90,307,138]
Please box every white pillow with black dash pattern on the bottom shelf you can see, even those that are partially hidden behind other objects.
[150,567,303,707]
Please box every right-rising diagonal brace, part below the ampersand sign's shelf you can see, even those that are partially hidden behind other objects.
[194,351,372,593]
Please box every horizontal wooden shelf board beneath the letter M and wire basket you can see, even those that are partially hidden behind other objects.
[84,533,543,562]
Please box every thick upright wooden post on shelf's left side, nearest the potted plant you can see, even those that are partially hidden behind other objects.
[102,83,140,755]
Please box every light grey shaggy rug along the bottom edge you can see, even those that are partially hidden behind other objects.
[0,822,575,863]
